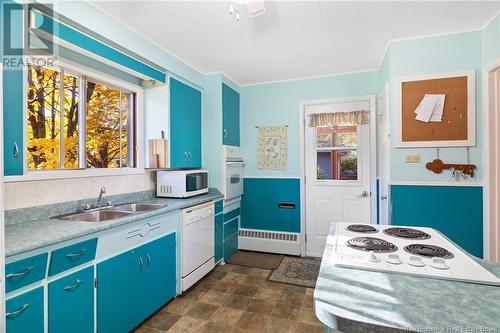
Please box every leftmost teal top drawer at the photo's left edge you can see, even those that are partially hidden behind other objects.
[5,253,48,292]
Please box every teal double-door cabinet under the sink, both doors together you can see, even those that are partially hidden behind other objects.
[97,233,176,333]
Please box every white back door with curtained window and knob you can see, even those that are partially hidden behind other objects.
[304,100,371,257]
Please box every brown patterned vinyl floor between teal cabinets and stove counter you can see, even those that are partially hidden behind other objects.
[136,264,324,333]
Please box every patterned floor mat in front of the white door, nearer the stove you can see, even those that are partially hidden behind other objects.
[268,257,321,288]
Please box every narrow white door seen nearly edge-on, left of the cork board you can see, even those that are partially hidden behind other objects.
[377,86,391,224]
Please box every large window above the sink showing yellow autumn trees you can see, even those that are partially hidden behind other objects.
[27,65,136,170]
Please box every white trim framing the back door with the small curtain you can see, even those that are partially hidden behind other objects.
[299,95,377,257]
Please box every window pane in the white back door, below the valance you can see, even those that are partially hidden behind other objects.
[316,125,358,180]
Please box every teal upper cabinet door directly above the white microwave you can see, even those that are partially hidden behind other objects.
[170,78,201,168]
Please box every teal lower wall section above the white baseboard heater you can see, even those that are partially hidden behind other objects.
[240,178,300,232]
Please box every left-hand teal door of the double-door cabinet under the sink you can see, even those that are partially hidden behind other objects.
[97,249,144,333]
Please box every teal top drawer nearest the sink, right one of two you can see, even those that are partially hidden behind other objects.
[49,238,97,276]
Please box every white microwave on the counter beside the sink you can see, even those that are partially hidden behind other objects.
[156,170,208,198]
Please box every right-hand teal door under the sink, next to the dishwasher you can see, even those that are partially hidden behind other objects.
[139,233,176,318]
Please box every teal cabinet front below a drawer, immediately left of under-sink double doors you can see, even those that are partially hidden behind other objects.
[49,266,94,333]
